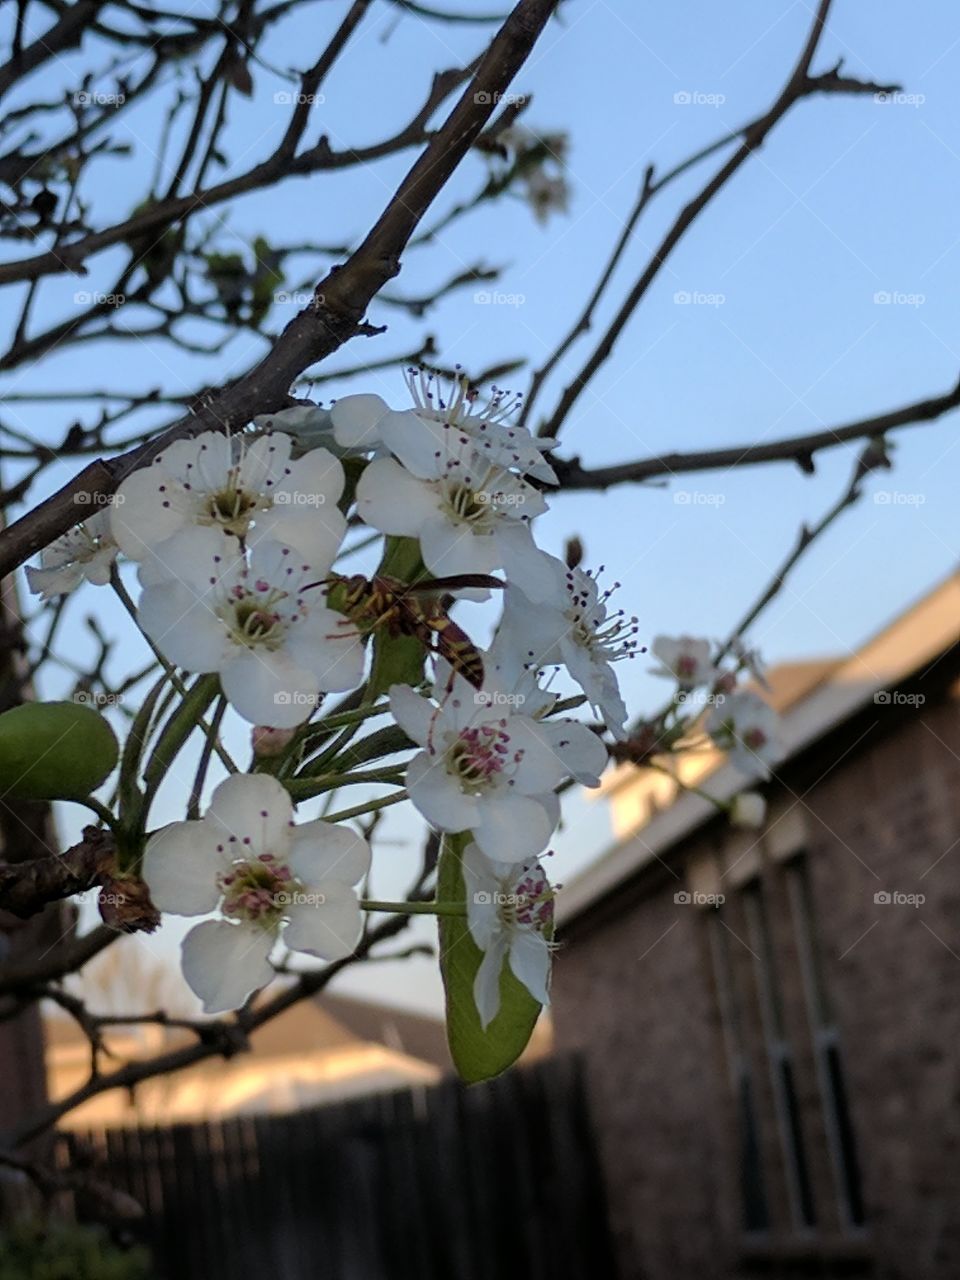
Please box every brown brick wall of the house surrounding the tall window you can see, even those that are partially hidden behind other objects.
[554,658,960,1280]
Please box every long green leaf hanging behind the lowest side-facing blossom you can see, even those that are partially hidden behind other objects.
[436,833,540,1084]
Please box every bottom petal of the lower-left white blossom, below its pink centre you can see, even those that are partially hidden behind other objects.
[183,920,275,1014]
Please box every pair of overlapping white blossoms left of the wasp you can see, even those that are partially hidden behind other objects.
[111,431,364,728]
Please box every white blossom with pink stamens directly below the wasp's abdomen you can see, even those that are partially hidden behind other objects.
[390,676,607,863]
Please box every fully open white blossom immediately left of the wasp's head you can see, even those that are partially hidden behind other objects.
[138,530,364,728]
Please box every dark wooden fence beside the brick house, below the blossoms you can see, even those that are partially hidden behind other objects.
[60,1057,614,1280]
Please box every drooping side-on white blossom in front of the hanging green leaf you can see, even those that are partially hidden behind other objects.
[462,845,553,1030]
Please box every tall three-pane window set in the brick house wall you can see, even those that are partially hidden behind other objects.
[705,855,864,1236]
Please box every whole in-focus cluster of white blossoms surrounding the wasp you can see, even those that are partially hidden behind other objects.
[24,371,647,1025]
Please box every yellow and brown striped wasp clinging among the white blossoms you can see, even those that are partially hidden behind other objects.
[326,573,503,689]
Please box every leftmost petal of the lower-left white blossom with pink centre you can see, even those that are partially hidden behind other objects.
[143,822,227,915]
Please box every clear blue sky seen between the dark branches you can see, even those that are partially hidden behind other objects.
[0,0,960,1002]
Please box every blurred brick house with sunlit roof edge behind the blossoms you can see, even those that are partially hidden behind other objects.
[553,576,960,1280]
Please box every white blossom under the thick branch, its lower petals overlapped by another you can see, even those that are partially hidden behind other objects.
[111,431,347,572]
